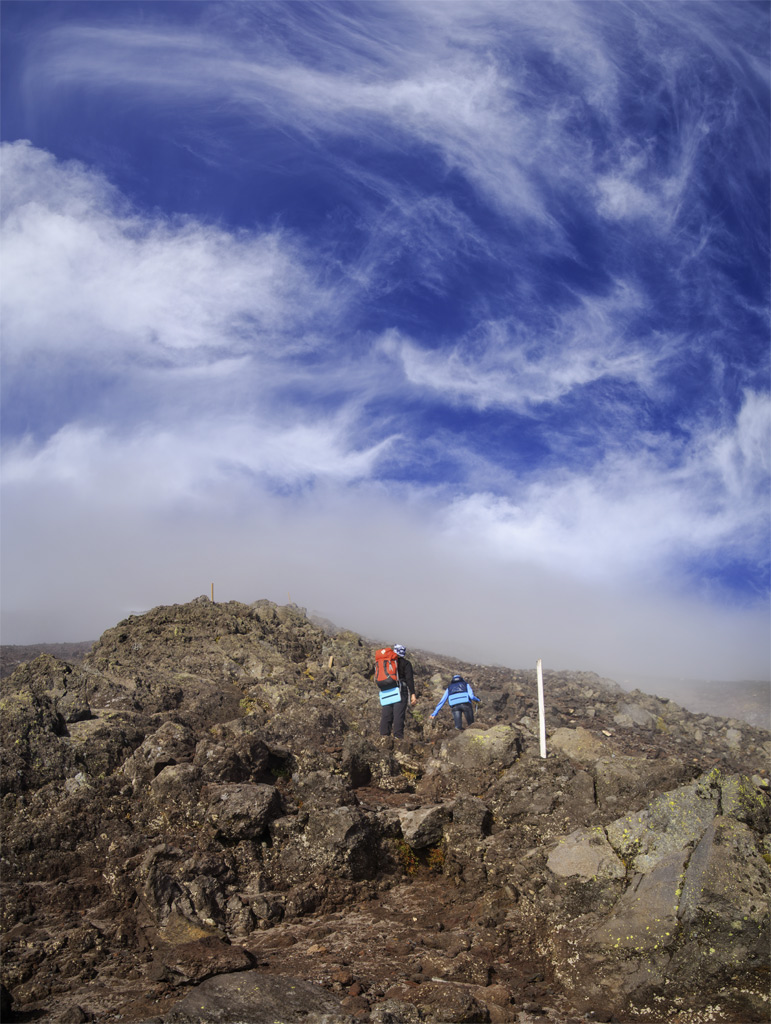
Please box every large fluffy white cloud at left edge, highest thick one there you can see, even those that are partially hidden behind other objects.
[2,142,330,361]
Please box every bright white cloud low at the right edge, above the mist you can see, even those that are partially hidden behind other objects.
[436,393,771,583]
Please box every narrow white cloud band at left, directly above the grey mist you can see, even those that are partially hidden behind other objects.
[3,414,394,499]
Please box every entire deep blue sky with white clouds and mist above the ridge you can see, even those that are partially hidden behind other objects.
[0,0,771,679]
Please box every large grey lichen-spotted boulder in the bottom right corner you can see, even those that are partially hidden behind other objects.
[548,772,771,1020]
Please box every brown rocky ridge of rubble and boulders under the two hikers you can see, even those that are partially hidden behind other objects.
[0,598,771,1024]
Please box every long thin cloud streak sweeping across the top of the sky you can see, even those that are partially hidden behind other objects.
[22,4,606,232]
